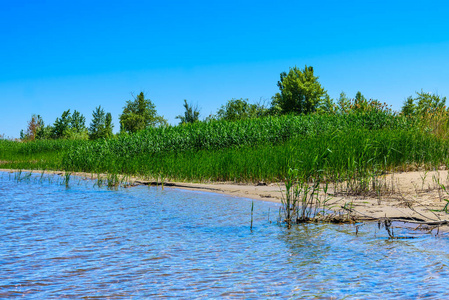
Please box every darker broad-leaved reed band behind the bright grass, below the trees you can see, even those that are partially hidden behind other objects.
[65,112,408,171]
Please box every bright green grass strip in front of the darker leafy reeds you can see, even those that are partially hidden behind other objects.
[59,129,449,182]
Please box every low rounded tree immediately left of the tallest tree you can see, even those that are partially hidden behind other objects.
[217,99,268,121]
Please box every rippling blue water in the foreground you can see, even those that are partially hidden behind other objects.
[0,172,449,299]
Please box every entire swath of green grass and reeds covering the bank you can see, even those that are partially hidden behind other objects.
[0,111,449,182]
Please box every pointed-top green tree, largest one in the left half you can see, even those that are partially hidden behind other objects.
[120,92,167,133]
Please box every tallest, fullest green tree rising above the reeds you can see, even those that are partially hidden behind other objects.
[272,66,327,114]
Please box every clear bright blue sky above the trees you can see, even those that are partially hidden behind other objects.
[0,0,449,137]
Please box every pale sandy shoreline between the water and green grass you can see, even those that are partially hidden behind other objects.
[0,168,449,226]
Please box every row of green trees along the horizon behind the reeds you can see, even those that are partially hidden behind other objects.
[20,66,447,140]
